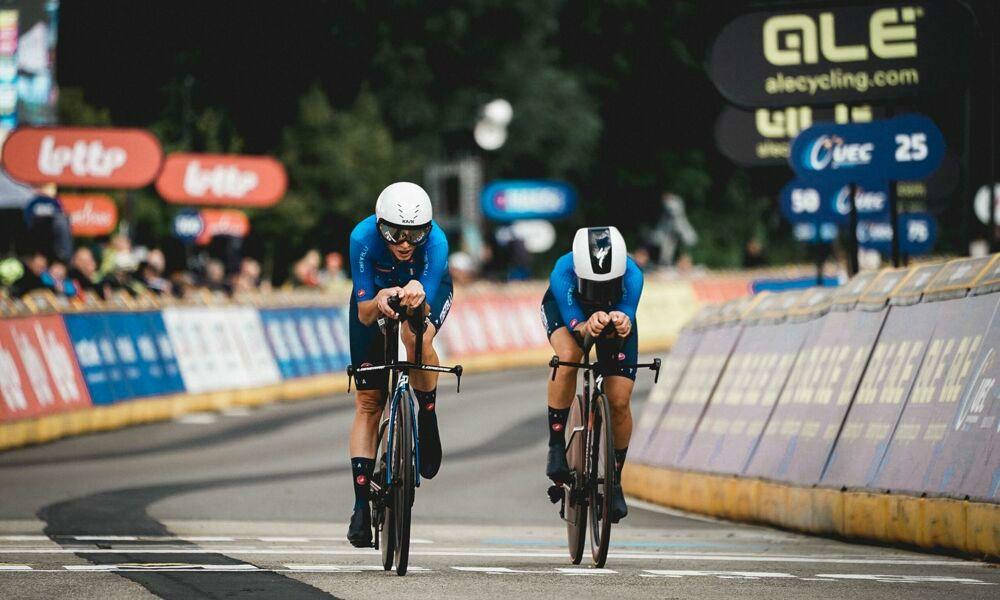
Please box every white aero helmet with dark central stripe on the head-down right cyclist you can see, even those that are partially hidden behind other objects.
[573,226,628,304]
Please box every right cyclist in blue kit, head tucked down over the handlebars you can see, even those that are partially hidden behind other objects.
[542,227,643,523]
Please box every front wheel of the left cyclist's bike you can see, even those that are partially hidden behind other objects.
[392,396,414,575]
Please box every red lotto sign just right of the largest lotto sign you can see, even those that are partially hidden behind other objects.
[156,153,288,206]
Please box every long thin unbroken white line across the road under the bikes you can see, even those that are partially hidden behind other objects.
[0,538,989,566]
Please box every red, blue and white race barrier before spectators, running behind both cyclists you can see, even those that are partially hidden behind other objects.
[0,276,750,450]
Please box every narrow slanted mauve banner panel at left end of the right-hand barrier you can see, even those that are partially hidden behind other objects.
[645,324,743,466]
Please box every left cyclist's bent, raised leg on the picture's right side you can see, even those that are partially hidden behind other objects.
[402,281,454,479]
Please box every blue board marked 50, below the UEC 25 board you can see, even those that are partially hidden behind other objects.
[780,179,889,225]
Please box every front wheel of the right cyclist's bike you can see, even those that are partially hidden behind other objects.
[588,394,617,569]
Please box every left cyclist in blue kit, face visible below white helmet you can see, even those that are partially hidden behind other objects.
[347,182,452,547]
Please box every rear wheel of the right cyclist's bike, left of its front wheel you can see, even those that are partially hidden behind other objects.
[563,395,587,565]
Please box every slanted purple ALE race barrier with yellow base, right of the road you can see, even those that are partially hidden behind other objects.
[623,255,1000,558]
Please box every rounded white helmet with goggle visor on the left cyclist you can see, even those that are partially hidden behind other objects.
[375,181,432,245]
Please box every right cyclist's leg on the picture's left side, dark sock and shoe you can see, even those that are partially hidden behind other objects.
[542,292,583,483]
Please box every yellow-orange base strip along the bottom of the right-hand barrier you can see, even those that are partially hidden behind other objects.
[622,463,1000,560]
